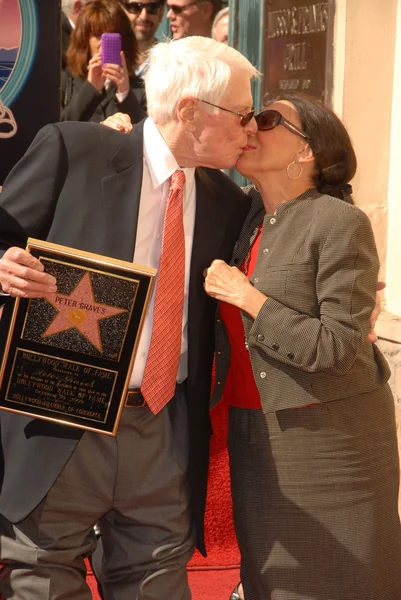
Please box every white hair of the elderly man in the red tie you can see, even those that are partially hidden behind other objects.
[145,36,259,125]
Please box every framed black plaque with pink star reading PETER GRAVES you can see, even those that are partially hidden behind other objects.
[0,238,156,436]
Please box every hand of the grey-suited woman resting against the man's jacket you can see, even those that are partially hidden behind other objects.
[204,260,266,318]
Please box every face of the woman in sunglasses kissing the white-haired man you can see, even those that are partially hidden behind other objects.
[235,100,306,181]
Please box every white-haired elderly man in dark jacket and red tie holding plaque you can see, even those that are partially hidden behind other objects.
[0,37,256,600]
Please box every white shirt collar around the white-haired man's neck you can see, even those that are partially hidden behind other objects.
[143,117,195,189]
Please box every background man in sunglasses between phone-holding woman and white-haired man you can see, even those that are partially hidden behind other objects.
[121,0,166,77]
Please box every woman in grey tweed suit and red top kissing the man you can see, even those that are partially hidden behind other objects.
[205,95,401,600]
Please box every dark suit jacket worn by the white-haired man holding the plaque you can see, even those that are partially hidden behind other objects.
[0,122,249,551]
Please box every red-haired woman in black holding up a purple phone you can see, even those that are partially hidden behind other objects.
[61,0,146,123]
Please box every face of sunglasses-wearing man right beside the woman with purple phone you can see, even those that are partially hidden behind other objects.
[122,0,164,42]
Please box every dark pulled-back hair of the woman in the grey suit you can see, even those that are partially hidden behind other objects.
[275,94,357,202]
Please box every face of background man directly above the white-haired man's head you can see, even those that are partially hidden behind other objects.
[167,0,213,40]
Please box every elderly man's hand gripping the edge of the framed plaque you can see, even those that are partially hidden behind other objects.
[0,247,57,298]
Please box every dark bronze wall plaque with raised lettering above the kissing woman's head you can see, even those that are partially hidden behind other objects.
[262,0,334,106]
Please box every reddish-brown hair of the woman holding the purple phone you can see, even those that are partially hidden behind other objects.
[66,0,138,79]
